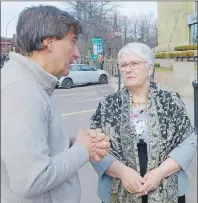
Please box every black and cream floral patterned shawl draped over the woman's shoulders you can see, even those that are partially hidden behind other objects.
[91,85,194,203]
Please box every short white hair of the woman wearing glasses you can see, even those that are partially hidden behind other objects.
[118,42,155,68]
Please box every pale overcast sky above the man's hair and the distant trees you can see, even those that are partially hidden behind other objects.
[1,1,157,37]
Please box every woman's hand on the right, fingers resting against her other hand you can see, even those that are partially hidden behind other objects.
[136,168,164,197]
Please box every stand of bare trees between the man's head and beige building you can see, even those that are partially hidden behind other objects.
[64,0,157,60]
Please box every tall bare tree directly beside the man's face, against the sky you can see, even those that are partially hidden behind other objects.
[69,0,114,59]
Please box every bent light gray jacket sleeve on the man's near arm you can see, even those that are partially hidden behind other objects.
[1,84,89,198]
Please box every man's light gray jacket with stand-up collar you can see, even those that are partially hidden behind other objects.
[1,53,89,203]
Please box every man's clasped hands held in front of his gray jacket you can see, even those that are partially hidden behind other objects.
[75,129,110,162]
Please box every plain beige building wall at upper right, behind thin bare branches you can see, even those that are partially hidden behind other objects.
[155,2,195,51]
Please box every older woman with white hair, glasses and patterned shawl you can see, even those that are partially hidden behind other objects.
[91,43,197,203]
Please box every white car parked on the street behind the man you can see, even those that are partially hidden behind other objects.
[57,64,111,89]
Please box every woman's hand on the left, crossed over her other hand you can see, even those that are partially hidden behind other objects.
[120,166,145,193]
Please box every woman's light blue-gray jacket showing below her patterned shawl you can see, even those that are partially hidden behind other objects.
[91,117,197,203]
